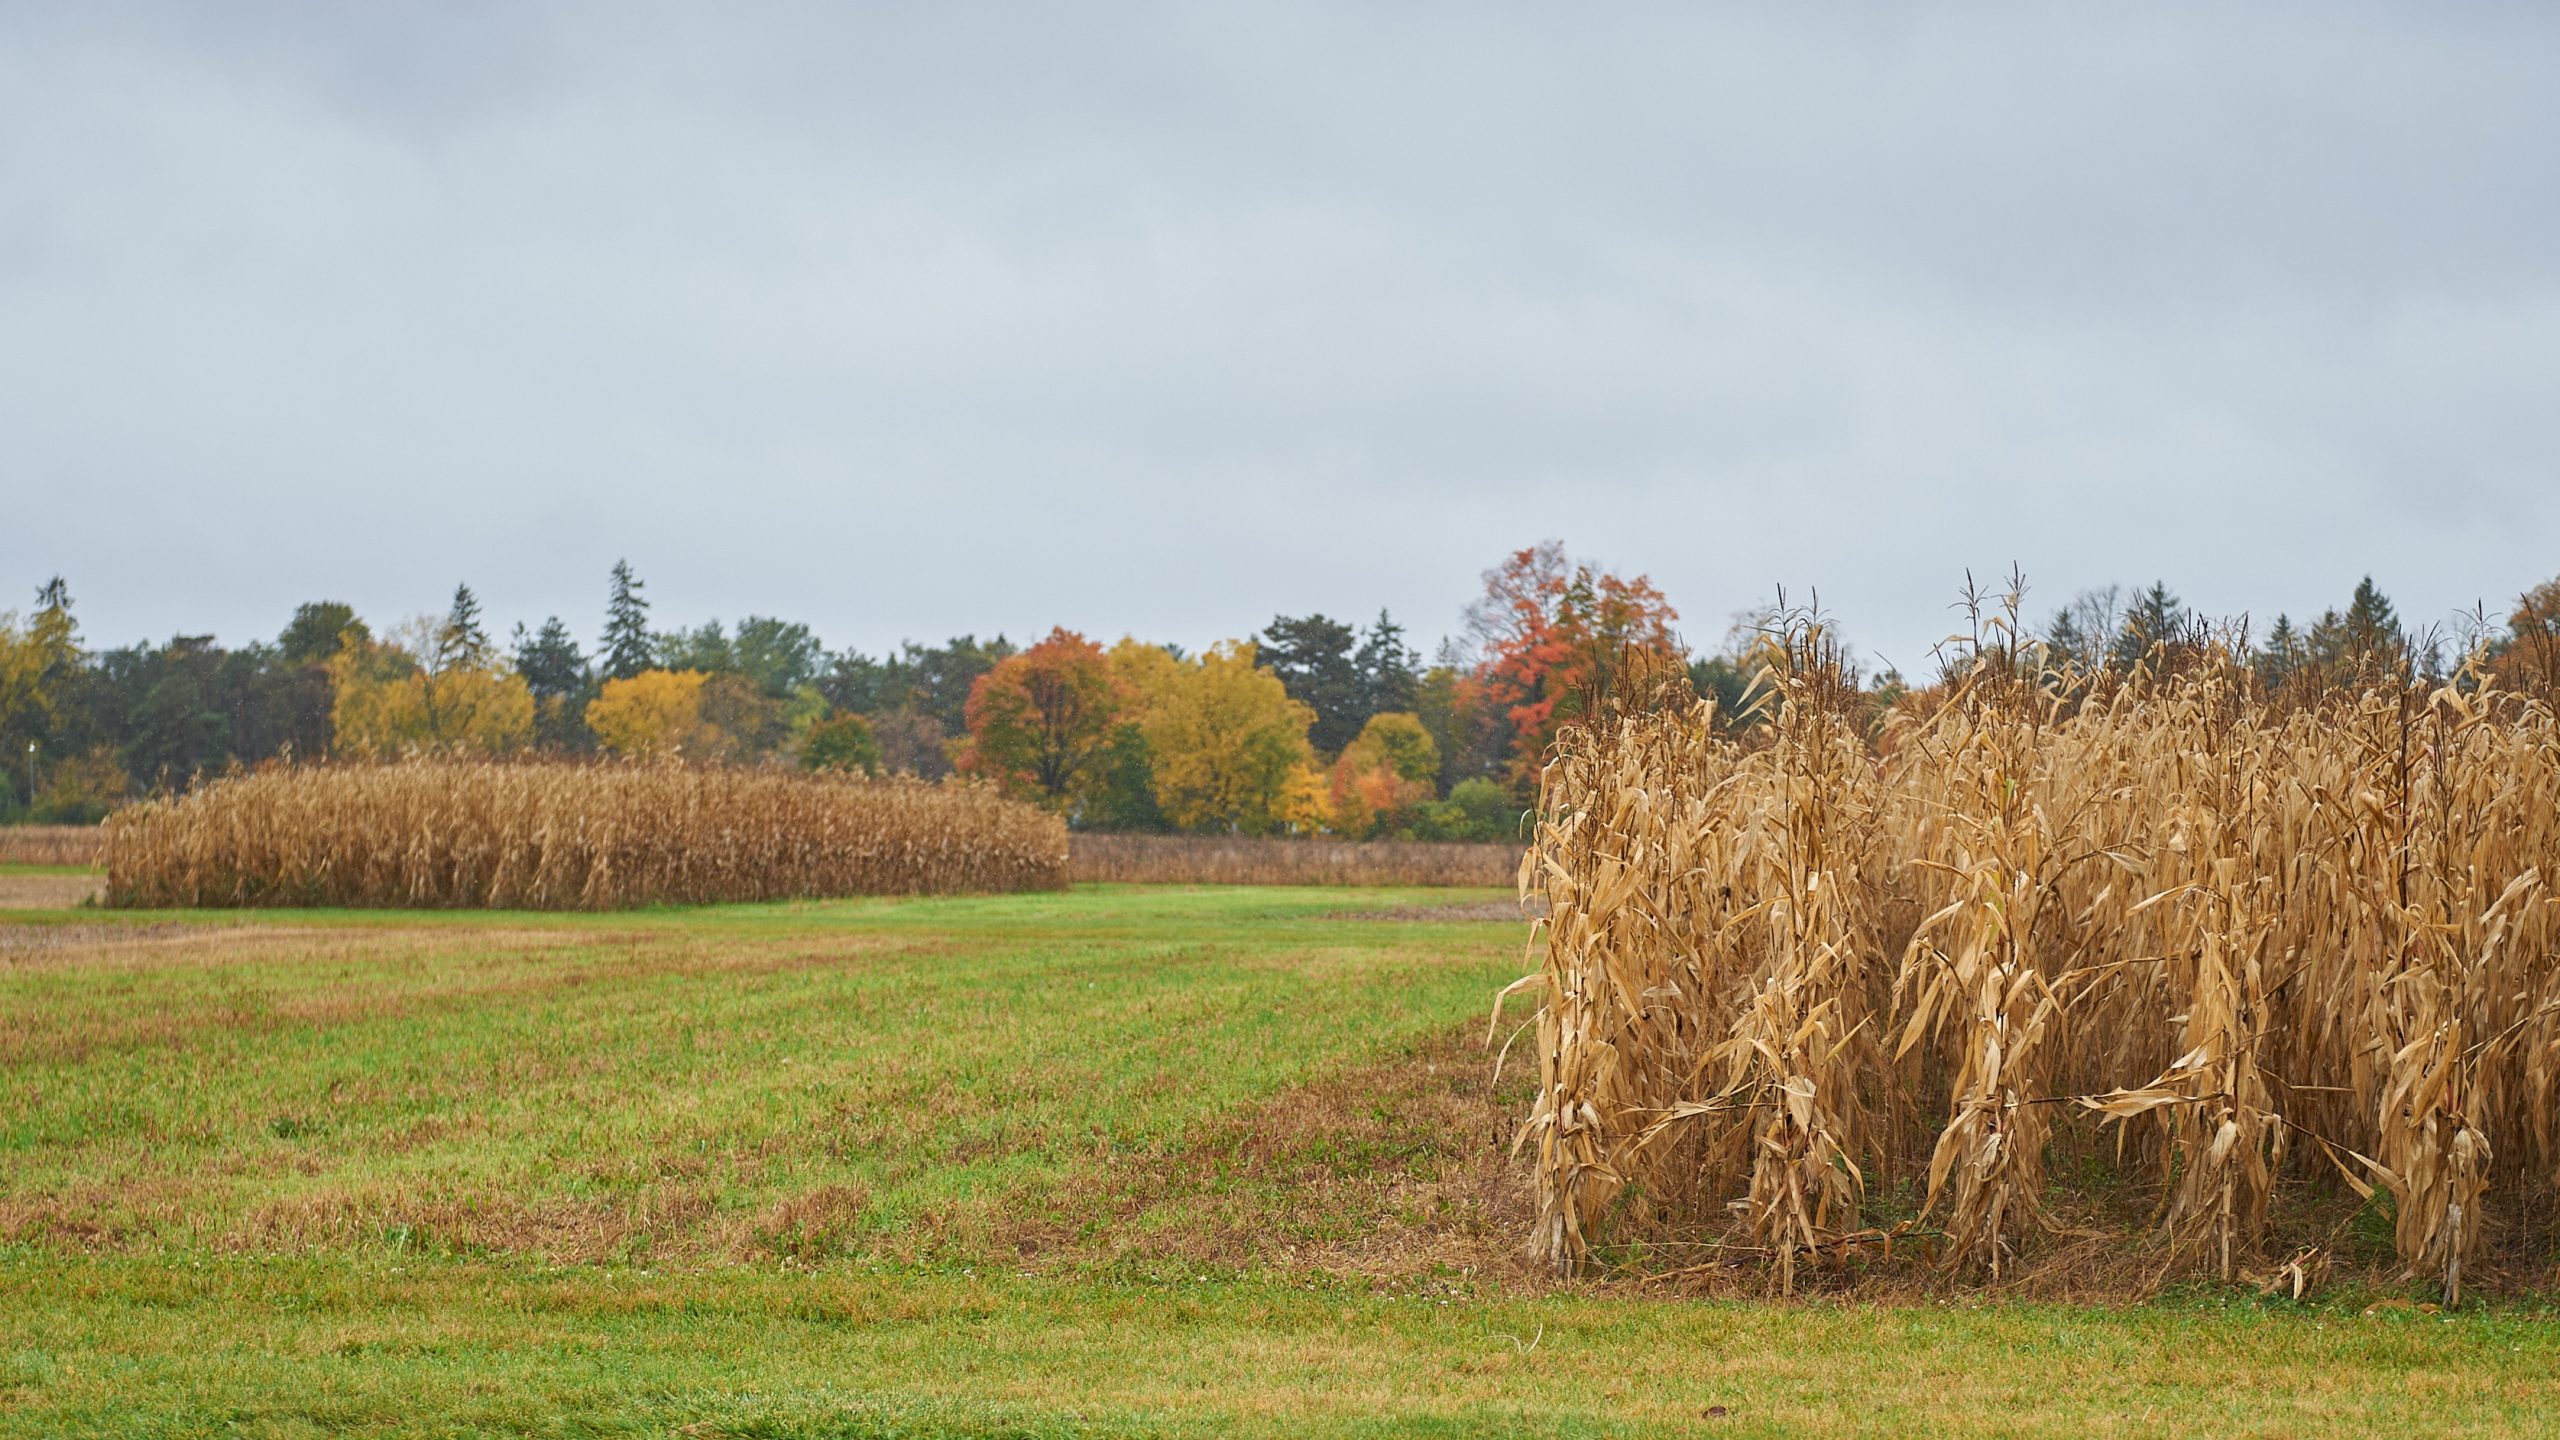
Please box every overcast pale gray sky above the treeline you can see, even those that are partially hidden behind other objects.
[0,0,2560,666]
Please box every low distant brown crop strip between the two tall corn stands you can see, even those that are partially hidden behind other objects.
[1073,835,1521,887]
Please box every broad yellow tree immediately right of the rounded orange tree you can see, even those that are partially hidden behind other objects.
[1136,641,1326,835]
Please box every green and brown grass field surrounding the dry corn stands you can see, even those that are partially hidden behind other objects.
[0,887,2560,1437]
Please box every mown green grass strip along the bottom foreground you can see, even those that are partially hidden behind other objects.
[0,1253,2560,1437]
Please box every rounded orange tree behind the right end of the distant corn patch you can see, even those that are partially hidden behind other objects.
[960,628,1121,810]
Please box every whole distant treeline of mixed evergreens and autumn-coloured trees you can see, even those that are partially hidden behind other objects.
[0,558,2560,840]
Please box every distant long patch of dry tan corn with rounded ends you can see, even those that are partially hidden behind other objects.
[105,758,1068,910]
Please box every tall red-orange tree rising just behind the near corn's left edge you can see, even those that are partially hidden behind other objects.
[1467,541,1679,789]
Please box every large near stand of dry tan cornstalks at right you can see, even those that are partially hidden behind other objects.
[1505,625,2560,1299]
